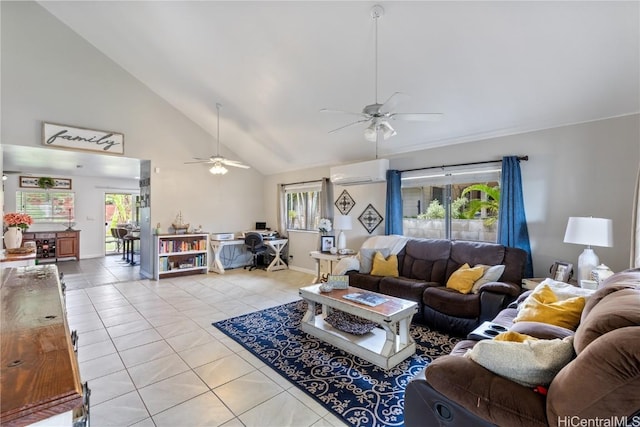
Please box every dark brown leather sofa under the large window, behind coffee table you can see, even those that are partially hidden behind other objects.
[348,239,526,336]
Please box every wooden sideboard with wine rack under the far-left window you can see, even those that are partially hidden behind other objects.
[22,230,80,261]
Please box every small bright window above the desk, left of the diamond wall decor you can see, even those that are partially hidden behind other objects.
[284,181,321,231]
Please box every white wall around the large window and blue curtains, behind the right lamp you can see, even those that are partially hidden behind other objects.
[264,115,640,276]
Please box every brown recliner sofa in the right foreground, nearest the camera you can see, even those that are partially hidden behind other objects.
[404,269,640,427]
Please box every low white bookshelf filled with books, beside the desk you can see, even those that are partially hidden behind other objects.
[154,233,209,280]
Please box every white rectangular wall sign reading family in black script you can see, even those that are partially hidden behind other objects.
[42,122,124,154]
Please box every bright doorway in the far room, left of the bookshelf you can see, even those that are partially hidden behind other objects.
[104,193,138,255]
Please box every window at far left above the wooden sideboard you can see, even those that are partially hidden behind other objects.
[16,190,75,224]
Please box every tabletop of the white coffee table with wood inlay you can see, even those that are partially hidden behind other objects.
[300,285,417,317]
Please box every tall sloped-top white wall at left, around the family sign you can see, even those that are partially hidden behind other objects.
[0,2,264,264]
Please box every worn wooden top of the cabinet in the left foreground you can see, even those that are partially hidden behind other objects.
[0,265,82,426]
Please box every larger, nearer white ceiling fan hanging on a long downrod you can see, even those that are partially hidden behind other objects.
[320,5,442,142]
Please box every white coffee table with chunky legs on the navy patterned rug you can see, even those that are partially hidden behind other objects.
[300,285,418,369]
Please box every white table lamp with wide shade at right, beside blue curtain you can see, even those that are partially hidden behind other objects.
[564,217,613,284]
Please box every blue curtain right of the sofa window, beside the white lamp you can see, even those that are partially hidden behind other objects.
[498,156,533,277]
